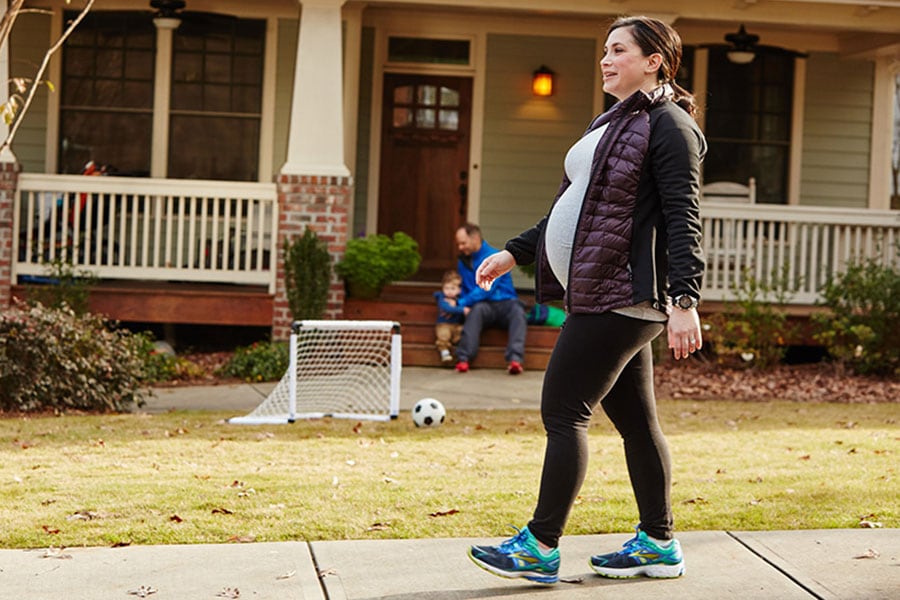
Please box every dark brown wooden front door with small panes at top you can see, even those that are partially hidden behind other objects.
[378,74,472,281]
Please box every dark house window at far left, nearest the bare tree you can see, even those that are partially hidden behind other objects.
[58,12,156,176]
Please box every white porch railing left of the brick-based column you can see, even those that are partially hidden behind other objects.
[13,174,278,292]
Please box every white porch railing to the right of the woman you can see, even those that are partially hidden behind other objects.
[700,202,900,304]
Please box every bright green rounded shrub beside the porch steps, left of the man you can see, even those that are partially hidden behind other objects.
[334,231,422,297]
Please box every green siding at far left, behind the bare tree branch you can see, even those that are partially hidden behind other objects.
[9,13,52,173]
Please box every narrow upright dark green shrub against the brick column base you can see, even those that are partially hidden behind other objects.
[284,228,331,320]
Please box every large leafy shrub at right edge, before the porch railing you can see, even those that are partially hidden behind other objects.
[813,253,900,375]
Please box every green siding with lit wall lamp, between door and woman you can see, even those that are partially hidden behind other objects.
[480,34,596,276]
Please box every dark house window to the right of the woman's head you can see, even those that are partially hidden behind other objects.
[703,48,794,204]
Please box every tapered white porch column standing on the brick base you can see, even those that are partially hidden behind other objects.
[281,0,350,177]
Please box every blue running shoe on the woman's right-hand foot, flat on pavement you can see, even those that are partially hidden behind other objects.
[591,528,684,578]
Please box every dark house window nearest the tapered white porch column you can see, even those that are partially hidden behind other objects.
[168,13,266,181]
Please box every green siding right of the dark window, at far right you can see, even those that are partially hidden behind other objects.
[800,54,874,208]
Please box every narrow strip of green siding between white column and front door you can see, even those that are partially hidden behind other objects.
[350,27,375,235]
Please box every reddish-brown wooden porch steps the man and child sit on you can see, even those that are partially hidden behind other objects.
[344,283,559,370]
